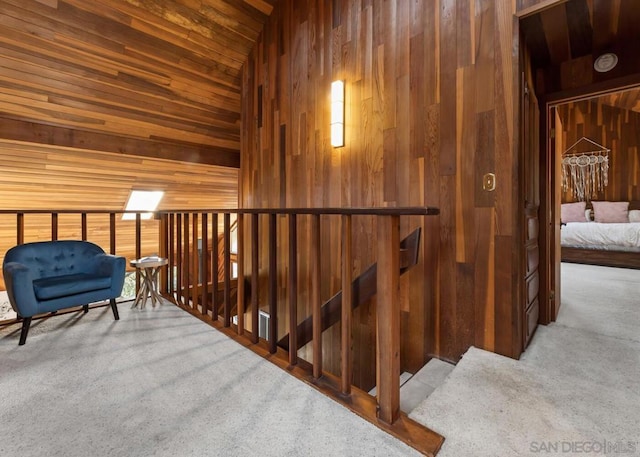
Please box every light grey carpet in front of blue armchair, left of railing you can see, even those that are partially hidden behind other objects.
[0,303,419,457]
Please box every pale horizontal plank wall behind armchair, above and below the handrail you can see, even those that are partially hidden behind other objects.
[0,140,238,288]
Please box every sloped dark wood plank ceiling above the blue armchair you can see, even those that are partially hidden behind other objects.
[0,0,276,167]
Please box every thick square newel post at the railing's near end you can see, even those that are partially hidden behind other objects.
[376,216,400,424]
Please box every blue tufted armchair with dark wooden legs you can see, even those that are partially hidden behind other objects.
[2,240,126,345]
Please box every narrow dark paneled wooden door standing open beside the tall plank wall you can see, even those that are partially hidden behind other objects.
[522,79,540,349]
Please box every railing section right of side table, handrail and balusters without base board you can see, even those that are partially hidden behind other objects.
[161,207,438,424]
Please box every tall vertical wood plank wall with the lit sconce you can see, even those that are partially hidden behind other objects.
[240,0,520,385]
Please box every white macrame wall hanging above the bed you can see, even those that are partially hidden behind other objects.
[562,137,611,201]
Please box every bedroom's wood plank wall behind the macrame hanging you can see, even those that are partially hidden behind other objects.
[558,99,640,201]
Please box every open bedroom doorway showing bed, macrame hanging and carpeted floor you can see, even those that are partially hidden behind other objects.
[548,87,640,338]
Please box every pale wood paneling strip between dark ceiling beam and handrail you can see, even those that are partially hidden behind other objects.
[0,139,238,210]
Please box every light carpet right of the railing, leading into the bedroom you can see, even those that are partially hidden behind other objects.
[410,265,640,457]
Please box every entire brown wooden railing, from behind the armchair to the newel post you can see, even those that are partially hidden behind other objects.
[0,207,442,454]
